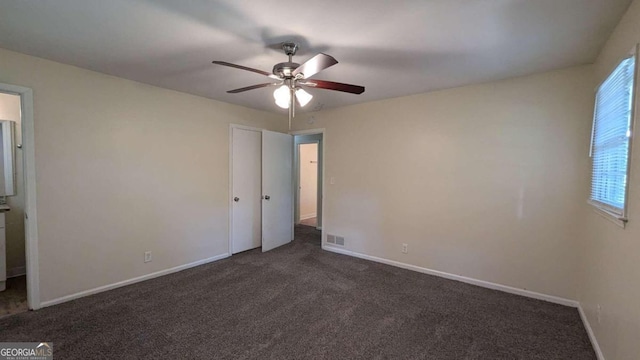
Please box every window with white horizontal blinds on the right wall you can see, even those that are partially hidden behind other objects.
[590,47,636,224]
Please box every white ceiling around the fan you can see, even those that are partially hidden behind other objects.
[0,0,631,113]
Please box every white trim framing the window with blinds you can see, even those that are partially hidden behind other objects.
[587,44,640,229]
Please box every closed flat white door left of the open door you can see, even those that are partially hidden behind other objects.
[231,128,262,254]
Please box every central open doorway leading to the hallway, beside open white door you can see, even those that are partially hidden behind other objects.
[294,133,323,229]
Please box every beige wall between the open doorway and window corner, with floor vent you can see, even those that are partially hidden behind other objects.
[296,66,593,299]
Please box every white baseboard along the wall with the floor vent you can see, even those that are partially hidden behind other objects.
[322,246,579,308]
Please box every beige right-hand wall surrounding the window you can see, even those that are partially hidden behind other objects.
[580,0,640,360]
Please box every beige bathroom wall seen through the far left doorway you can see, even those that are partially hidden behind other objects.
[0,93,25,276]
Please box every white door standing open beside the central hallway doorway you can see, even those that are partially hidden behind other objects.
[262,130,293,252]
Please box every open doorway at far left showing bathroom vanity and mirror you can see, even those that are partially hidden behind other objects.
[0,92,29,317]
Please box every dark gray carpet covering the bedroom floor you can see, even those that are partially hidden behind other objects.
[0,227,595,360]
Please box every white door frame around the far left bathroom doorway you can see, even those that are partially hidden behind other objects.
[0,83,41,310]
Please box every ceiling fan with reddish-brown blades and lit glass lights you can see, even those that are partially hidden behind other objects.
[213,42,364,130]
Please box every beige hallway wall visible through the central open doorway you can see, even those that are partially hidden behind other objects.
[299,144,318,219]
